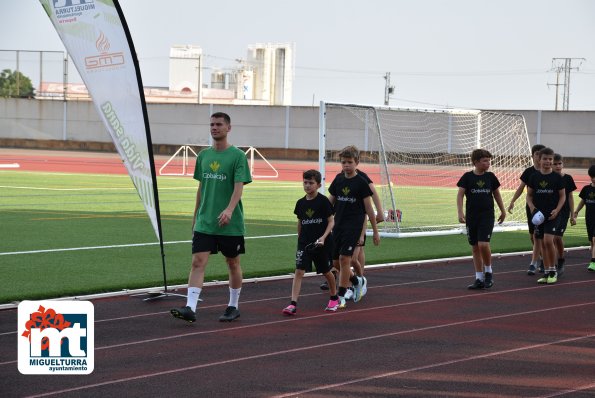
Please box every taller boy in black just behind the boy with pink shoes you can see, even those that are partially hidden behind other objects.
[329,146,380,308]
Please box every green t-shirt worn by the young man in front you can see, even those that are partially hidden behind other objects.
[194,145,252,236]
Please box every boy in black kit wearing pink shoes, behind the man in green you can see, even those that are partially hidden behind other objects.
[283,170,339,315]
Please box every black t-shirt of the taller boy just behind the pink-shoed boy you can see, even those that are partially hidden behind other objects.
[328,174,372,230]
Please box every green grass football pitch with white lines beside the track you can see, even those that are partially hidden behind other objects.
[0,170,588,303]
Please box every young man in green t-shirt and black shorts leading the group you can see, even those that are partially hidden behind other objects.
[171,112,252,322]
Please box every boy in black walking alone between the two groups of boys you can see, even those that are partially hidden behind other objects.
[457,149,506,290]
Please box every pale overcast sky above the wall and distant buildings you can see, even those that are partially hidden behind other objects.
[0,0,595,110]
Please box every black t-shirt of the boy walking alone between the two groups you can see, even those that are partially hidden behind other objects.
[457,171,500,217]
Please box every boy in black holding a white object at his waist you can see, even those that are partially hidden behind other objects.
[527,148,566,284]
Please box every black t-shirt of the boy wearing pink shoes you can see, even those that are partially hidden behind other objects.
[293,194,333,245]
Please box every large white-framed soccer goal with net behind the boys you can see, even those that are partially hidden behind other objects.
[319,102,532,237]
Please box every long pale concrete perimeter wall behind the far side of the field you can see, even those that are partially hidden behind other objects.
[0,98,595,163]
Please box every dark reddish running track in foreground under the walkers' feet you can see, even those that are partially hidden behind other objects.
[0,250,595,397]
